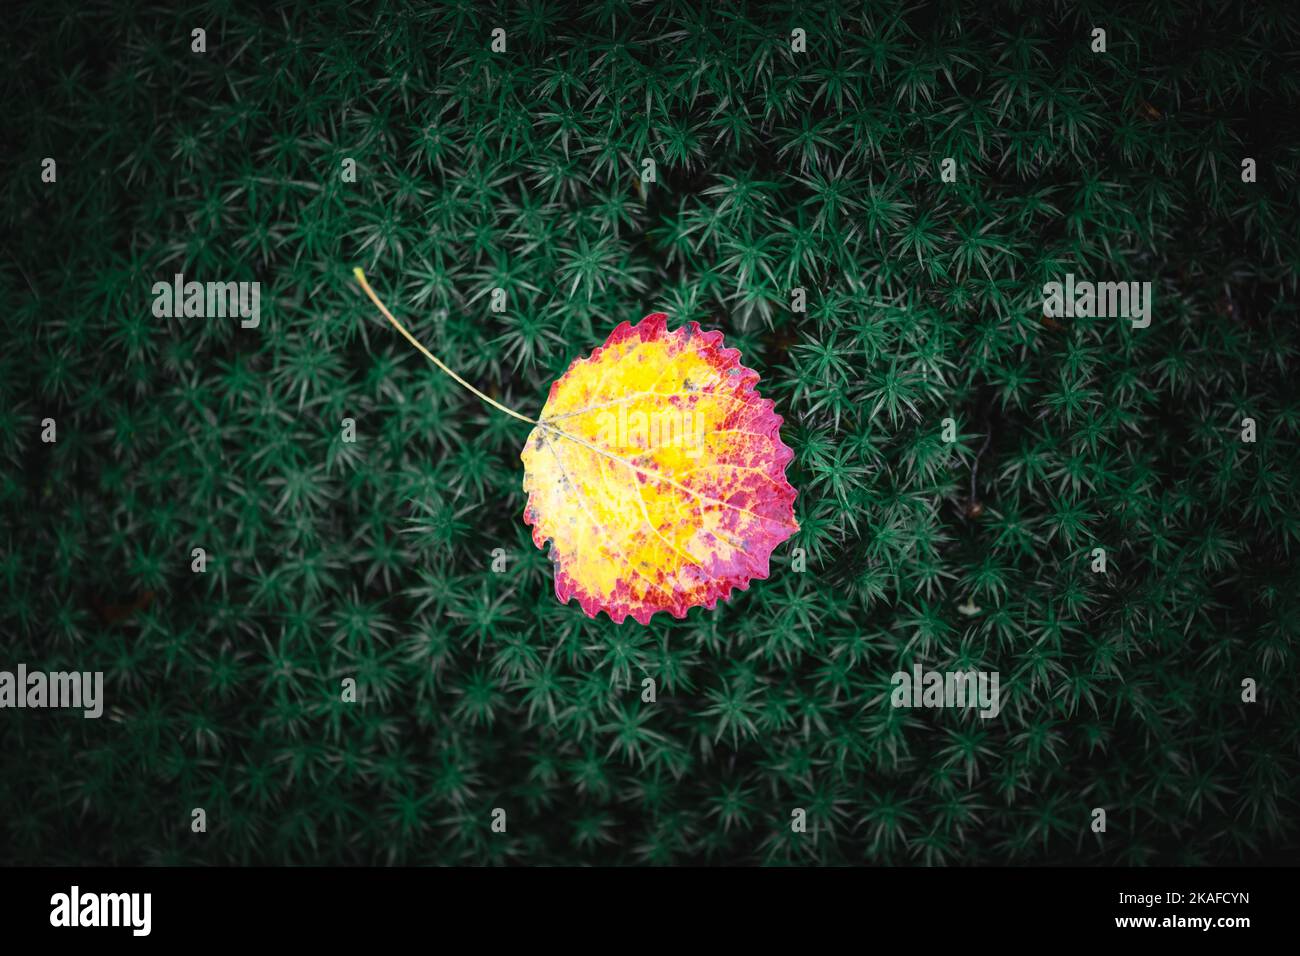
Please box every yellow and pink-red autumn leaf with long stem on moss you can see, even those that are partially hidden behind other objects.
[356,269,798,624]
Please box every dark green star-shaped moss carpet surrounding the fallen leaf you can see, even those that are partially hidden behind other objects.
[0,0,1300,864]
